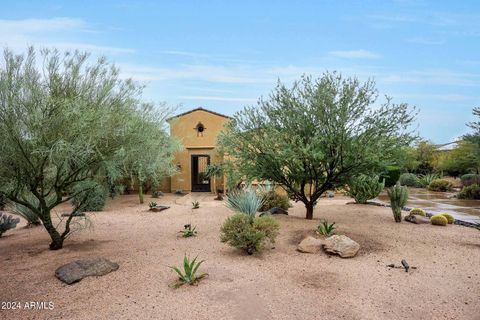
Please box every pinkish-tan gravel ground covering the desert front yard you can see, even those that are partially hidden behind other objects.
[0,194,480,320]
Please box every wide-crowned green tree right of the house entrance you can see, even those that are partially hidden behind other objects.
[220,73,415,219]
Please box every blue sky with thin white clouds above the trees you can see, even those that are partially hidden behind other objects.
[0,0,480,143]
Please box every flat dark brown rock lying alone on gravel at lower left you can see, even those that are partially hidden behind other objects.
[55,257,119,284]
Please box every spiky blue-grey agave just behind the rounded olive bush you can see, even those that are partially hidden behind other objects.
[227,186,264,219]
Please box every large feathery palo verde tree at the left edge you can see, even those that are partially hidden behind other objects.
[0,48,178,250]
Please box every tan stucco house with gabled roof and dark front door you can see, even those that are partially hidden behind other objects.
[162,108,231,192]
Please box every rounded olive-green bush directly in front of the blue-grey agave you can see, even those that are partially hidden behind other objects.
[220,213,280,255]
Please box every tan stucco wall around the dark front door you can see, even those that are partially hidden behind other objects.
[169,110,229,192]
